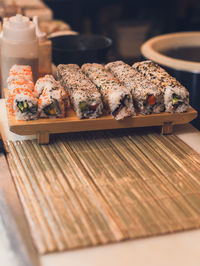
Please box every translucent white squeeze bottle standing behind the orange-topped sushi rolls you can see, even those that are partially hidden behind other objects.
[1,14,38,97]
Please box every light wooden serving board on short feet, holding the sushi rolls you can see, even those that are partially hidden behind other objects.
[8,107,197,144]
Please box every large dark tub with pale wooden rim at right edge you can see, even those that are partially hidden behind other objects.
[141,32,200,129]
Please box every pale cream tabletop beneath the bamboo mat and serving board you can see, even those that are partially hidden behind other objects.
[0,100,200,266]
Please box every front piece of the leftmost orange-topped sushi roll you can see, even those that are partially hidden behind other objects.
[13,88,38,120]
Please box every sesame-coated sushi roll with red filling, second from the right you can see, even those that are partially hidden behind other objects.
[105,61,164,114]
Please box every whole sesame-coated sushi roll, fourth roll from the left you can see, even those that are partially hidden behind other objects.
[81,63,135,120]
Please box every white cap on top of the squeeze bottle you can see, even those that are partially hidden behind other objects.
[3,14,36,42]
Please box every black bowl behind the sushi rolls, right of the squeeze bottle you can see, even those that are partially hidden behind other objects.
[50,34,112,66]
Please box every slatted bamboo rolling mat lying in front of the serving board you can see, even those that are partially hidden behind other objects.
[7,130,200,254]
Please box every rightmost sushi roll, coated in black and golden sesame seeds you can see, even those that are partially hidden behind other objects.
[133,60,189,113]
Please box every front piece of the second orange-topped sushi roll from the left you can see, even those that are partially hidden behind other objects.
[38,83,66,118]
